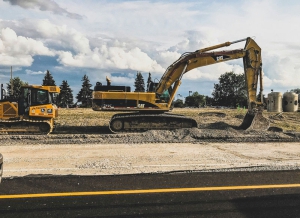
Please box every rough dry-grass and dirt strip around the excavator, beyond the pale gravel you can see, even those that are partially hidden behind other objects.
[0,109,300,146]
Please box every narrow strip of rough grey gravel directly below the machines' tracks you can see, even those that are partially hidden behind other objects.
[0,127,300,146]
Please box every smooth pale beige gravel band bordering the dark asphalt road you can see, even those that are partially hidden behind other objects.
[1,142,300,179]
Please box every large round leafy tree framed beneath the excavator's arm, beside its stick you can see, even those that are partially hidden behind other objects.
[212,72,248,107]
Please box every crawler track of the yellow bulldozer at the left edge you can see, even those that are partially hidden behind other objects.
[0,119,54,135]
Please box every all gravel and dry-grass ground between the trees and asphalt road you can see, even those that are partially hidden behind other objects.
[0,110,300,177]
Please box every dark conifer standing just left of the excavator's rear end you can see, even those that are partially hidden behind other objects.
[76,75,93,107]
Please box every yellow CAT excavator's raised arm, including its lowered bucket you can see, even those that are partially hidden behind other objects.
[156,37,269,129]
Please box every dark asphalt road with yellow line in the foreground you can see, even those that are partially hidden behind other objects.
[0,171,300,218]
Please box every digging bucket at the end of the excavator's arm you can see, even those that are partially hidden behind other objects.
[240,110,270,131]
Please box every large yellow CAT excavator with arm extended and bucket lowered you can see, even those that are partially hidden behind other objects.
[92,37,269,132]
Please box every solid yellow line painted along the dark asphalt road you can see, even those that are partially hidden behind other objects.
[0,184,300,199]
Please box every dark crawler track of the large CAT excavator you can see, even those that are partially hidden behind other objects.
[109,113,197,133]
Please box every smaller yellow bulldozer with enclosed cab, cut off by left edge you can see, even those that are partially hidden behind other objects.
[0,84,60,134]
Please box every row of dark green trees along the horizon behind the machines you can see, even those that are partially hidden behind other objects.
[7,70,300,107]
